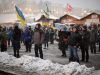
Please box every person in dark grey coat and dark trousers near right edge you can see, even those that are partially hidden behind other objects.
[90,26,98,54]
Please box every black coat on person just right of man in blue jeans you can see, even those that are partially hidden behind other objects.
[80,30,90,49]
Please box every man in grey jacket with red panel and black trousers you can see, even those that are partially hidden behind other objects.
[34,24,44,59]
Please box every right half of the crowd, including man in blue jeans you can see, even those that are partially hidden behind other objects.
[58,23,100,63]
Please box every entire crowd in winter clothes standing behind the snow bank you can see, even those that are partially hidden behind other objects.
[0,23,100,63]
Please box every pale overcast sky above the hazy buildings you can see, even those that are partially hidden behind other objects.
[33,0,100,10]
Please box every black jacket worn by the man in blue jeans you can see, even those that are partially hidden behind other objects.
[68,32,82,47]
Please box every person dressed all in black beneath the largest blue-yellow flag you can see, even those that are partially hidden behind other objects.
[12,23,21,58]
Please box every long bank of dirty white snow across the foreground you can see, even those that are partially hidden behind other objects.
[0,53,94,75]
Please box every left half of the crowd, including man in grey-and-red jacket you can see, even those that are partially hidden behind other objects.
[0,23,55,59]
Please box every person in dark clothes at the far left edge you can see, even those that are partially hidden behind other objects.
[0,27,6,52]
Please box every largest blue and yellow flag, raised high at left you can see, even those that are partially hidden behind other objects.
[15,5,26,26]
